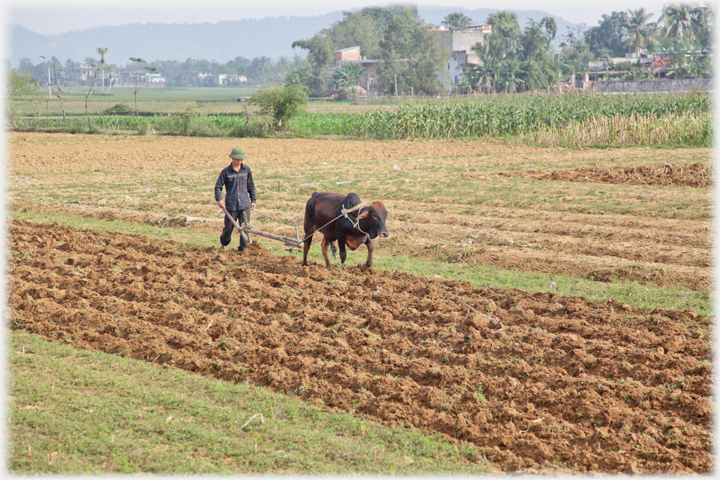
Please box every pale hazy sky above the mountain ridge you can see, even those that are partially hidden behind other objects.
[3,0,672,34]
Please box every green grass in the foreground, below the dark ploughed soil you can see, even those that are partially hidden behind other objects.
[7,332,487,475]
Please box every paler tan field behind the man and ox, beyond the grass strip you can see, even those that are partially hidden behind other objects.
[10,133,713,292]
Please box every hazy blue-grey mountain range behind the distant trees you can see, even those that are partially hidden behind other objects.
[6,6,582,67]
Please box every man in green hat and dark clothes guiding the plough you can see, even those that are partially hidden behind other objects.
[215,147,256,252]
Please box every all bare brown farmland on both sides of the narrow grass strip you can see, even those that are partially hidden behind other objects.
[8,133,714,473]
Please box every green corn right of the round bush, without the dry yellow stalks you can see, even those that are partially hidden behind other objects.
[291,93,712,140]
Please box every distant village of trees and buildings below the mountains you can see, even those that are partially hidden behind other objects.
[12,7,714,97]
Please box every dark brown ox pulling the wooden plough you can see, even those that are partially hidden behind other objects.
[302,192,390,271]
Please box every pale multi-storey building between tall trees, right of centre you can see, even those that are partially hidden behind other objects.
[431,25,492,91]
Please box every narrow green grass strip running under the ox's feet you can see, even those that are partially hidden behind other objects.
[8,211,713,318]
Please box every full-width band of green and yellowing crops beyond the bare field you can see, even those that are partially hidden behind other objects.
[11,92,713,146]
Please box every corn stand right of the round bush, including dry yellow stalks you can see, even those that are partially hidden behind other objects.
[291,93,712,146]
